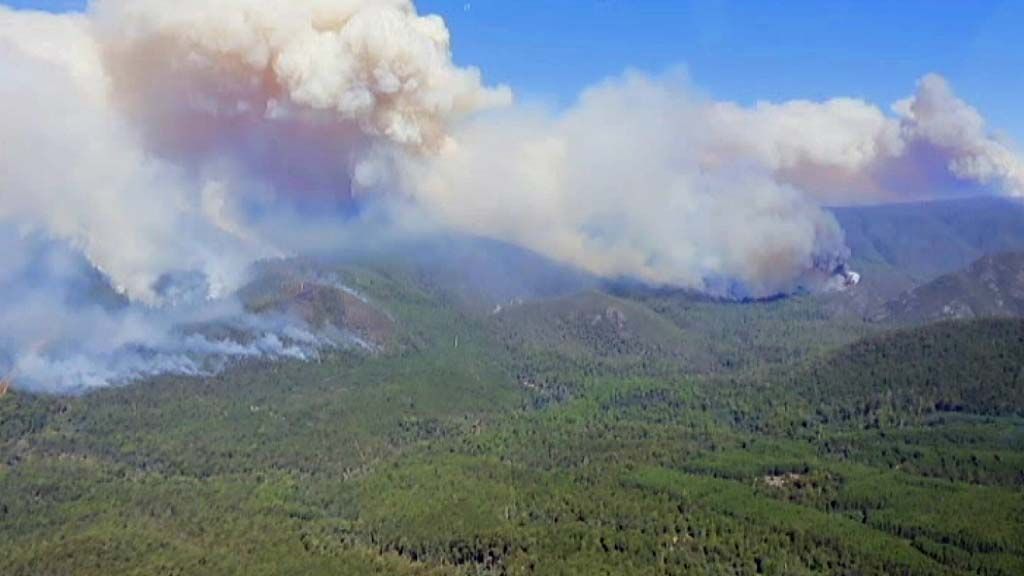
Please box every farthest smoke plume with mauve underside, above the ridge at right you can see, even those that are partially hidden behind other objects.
[701,74,1024,205]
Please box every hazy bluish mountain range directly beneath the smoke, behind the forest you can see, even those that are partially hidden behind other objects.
[230,198,1024,368]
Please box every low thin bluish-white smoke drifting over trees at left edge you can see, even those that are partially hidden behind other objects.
[0,230,335,393]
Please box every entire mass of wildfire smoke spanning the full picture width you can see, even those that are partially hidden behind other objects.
[0,0,1024,389]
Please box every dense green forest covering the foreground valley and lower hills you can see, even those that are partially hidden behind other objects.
[0,256,1024,576]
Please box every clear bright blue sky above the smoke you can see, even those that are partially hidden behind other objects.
[8,0,1024,145]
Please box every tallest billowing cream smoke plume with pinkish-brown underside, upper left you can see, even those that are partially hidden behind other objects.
[93,0,511,199]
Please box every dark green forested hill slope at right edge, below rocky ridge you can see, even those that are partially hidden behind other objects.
[785,319,1024,420]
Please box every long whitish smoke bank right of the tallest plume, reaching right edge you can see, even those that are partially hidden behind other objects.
[402,74,1024,296]
